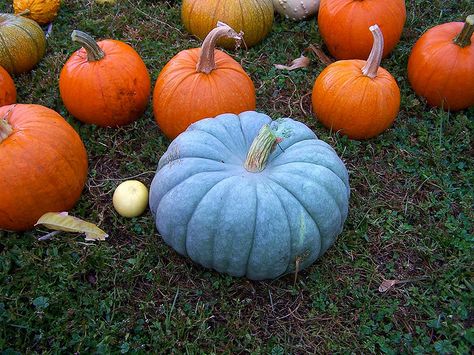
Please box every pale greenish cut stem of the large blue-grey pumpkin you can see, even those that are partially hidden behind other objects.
[244,125,281,173]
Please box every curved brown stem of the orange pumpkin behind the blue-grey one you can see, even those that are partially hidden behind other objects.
[196,21,244,74]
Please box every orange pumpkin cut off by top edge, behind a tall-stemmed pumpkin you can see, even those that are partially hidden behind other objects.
[318,0,406,59]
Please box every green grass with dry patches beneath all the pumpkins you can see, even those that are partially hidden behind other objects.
[0,0,474,354]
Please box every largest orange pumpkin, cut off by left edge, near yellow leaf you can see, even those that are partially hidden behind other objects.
[0,104,87,231]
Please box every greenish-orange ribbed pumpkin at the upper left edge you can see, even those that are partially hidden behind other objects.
[0,14,46,74]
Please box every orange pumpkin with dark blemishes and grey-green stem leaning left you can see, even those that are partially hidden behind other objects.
[59,30,151,127]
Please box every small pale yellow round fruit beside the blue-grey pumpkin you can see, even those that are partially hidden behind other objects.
[112,180,148,218]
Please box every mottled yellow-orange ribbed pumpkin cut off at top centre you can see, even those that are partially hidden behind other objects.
[181,0,274,49]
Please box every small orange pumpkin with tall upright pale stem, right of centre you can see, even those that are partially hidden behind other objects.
[312,25,400,139]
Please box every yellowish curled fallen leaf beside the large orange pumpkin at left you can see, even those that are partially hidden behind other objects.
[35,212,108,240]
